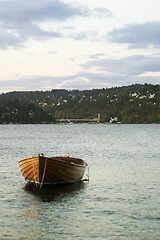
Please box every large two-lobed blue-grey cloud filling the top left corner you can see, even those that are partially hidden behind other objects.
[0,0,89,49]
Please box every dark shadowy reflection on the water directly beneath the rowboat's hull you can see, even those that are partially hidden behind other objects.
[23,181,87,202]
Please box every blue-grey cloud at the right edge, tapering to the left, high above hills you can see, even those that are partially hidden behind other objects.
[106,21,160,48]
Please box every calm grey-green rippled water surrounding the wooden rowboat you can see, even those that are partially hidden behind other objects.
[0,124,160,240]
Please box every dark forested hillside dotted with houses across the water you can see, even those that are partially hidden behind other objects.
[0,84,160,123]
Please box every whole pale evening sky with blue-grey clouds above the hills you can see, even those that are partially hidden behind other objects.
[0,0,160,93]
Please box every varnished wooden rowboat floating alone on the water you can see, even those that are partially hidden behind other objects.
[19,155,87,186]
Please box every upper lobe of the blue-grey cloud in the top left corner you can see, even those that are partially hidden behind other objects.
[0,0,87,26]
